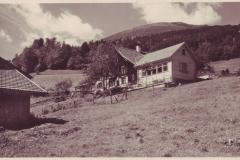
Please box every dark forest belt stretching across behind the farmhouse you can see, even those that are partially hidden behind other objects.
[13,24,240,75]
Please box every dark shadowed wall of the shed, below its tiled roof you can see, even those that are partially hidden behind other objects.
[0,94,30,126]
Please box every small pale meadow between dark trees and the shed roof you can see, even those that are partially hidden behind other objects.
[32,70,86,89]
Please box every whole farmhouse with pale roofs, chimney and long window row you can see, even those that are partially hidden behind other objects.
[109,42,197,86]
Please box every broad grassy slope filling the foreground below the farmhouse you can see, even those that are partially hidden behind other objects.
[0,77,240,157]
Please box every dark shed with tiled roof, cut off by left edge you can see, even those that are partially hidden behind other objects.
[0,57,47,126]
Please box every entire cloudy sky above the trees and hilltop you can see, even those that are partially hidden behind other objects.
[0,0,240,59]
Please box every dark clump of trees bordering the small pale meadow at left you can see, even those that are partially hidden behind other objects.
[13,38,94,73]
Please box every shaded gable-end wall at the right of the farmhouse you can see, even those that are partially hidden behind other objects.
[172,46,197,80]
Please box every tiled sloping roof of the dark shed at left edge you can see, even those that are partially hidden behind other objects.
[0,58,47,94]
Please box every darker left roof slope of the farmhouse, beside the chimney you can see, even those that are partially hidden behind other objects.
[116,47,144,65]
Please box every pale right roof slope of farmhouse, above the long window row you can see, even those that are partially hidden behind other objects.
[135,42,185,66]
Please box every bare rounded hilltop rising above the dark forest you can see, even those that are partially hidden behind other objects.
[104,22,200,41]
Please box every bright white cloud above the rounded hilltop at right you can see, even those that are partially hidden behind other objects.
[133,1,221,25]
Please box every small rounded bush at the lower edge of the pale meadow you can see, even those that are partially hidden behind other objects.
[55,79,72,94]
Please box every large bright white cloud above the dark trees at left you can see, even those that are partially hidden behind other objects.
[10,3,102,47]
